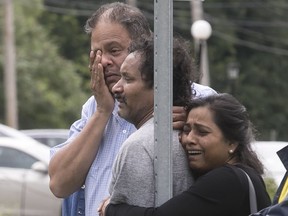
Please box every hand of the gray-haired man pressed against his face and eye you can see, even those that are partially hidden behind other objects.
[89,50,114,113]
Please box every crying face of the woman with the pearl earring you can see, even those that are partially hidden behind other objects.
[181,106,236,174]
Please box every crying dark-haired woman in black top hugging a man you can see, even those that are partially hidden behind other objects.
[105,94,270,216]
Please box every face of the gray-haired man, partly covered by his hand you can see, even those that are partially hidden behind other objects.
[91,20,131,91]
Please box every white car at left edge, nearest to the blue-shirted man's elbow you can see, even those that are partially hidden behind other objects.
[0,137,62,216]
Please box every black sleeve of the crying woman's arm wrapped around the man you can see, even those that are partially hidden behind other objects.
[106,166,249,216]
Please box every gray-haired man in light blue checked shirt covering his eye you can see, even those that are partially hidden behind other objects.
[49,2,214,216]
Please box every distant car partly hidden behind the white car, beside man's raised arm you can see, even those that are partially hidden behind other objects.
[21,129,69,147]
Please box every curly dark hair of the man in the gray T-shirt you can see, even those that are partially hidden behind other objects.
[128,36,195,106]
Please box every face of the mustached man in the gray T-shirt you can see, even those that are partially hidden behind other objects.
[112,52,154,127]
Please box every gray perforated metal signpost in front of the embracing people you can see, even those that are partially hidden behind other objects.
[154,0,173,206]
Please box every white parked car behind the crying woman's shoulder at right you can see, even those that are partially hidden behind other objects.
[252,141,288,186]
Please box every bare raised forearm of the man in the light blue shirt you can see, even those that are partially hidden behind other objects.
[49,111,110,198]
